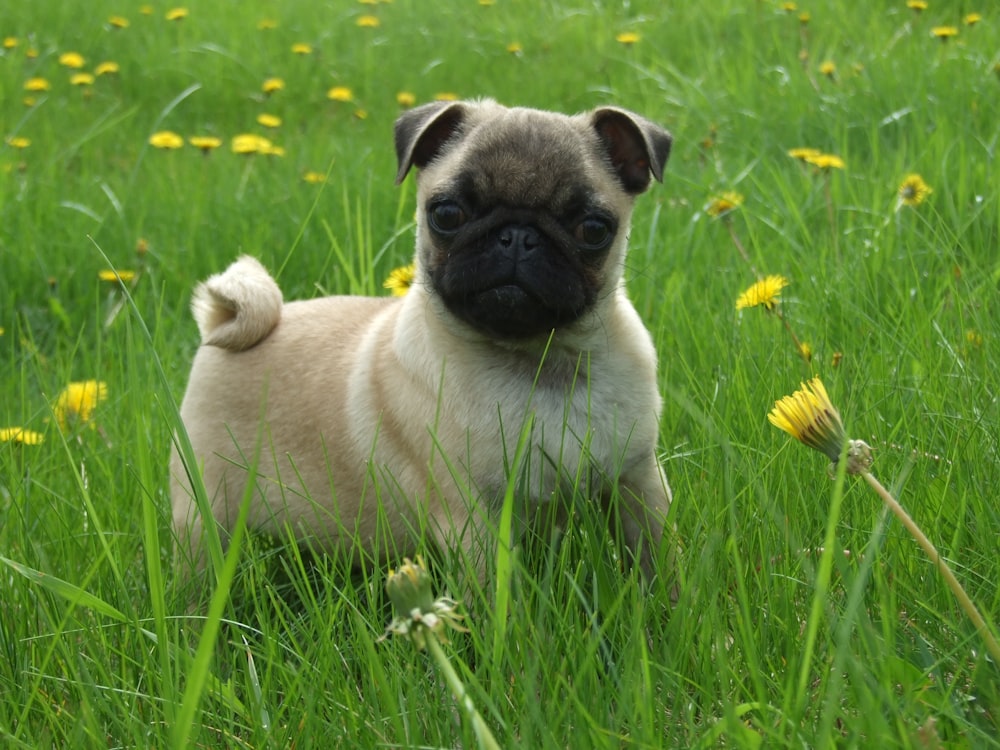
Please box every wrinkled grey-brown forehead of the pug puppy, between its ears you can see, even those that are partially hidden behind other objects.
[446,110,597,211]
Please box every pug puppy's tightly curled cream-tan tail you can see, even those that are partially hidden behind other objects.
[191,255,282,352]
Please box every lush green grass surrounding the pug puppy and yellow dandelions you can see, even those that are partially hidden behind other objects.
[0,0,1000,748]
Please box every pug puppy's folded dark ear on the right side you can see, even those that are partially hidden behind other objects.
[591,107,673,195]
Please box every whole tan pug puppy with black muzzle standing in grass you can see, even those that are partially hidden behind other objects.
[171,100,671,588]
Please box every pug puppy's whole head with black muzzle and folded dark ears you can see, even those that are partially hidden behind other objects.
[396,101,670,339]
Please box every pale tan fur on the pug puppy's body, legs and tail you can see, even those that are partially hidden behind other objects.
[171,101,670,588]
